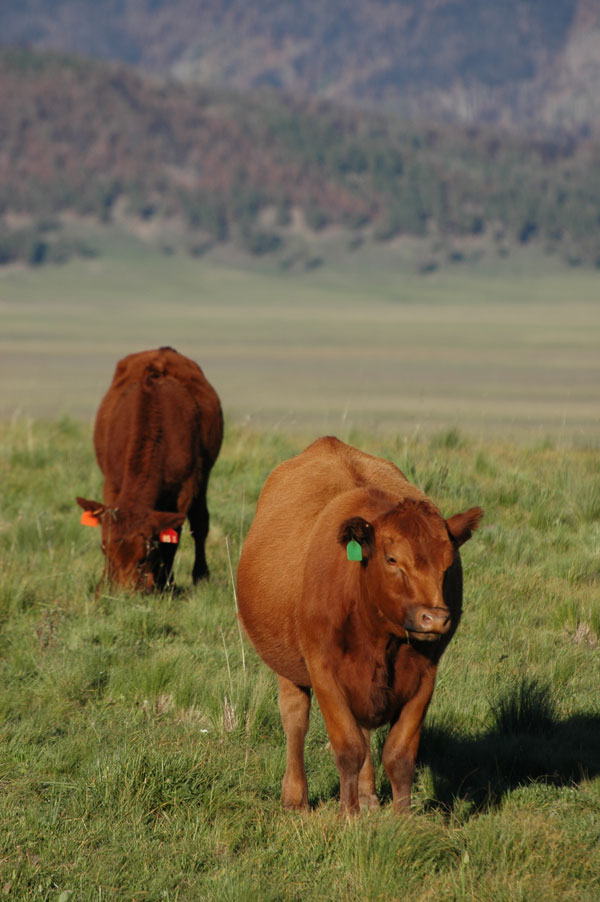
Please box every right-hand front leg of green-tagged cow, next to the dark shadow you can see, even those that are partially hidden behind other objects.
[383,668,435,814]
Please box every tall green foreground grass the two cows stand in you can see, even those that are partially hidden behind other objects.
[0,420,600,902]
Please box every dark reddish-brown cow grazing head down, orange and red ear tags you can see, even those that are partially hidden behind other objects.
[77,347,223,590]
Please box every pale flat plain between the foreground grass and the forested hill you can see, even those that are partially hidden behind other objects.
[0,235,600,444]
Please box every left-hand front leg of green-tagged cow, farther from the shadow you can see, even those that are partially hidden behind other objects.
[313,672,369,814]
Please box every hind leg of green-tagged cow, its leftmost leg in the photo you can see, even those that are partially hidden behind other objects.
[277,677,310,808]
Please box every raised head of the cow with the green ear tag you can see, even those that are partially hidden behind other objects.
[338,499,483,641]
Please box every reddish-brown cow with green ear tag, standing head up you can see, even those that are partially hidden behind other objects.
[238,438,483,812]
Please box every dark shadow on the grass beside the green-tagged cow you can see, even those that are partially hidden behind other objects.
[418,679,600,811]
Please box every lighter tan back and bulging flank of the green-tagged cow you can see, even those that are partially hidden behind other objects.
[238,437,423,683]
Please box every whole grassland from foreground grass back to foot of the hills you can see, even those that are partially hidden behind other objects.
[0,248,600,902]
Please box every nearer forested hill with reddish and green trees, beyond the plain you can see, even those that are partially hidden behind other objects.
[0,50,600,264]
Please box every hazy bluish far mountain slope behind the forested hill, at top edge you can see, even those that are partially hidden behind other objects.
[0,0,600,132]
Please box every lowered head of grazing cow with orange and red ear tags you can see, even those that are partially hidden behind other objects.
[76,497,185,591]
